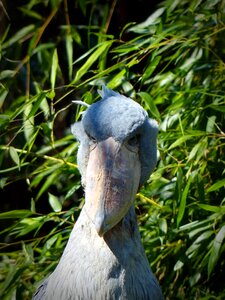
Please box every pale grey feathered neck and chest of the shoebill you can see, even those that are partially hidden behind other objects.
[33,207,163,300]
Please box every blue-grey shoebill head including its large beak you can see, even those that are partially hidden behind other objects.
[72,86,158,236]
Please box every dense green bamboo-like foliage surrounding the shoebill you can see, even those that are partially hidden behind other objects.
[0,0,225,299]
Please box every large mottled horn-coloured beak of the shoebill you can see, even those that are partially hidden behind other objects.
[85,138,141,236]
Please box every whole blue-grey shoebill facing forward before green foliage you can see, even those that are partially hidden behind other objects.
[33,87,163,300]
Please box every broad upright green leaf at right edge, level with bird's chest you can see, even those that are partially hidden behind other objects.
[208,225,225,277]
